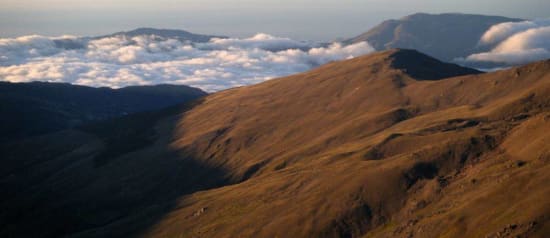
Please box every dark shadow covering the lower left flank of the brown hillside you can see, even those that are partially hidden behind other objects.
[0,97,229,237]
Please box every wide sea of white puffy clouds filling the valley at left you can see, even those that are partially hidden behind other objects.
[0,34,374,92]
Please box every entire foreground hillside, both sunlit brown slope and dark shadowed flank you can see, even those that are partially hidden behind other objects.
[0,50,550,237]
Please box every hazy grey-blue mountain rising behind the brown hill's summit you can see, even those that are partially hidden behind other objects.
[345,13,522,61]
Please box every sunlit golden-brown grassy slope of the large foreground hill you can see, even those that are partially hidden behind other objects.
[147,50,550,237]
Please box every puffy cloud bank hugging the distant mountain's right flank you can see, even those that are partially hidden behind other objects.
[466,19,550,65]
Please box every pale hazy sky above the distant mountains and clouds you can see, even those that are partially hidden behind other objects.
[0,0,550,41]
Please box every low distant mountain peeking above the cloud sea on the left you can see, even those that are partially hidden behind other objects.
[95,28,227,42]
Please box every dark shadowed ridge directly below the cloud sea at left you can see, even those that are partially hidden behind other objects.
[0,82,206,142]
